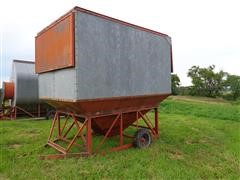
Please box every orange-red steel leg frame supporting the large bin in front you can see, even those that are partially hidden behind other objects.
[40,107,159,159]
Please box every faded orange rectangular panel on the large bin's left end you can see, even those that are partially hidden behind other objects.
[35,13,74,73]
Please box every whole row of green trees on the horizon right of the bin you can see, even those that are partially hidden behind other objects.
[171,65,240,100]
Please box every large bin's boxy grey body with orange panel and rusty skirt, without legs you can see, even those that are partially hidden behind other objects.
[36,8,172,114]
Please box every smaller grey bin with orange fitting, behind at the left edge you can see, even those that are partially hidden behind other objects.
[1,60,50,119]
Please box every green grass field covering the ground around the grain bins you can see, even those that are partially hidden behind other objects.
[0,97,240,179]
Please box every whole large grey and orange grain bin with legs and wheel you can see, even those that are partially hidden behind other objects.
[35,7,172,157]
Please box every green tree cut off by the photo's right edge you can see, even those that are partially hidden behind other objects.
[225,74,240,100]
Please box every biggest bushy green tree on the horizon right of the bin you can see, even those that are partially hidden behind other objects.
[187,65,226,97]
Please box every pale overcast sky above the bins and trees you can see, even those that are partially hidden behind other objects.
[0,0,240,86]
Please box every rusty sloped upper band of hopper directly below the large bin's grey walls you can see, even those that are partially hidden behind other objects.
[43,94,170,116]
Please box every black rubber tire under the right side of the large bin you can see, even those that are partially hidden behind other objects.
[133,129,152,149]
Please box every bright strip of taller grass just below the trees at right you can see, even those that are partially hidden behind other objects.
[161,97,240,121]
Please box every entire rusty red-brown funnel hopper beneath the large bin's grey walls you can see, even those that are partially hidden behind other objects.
[43,94,169,136]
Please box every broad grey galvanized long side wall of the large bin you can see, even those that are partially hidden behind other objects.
[75,12,171,99]
